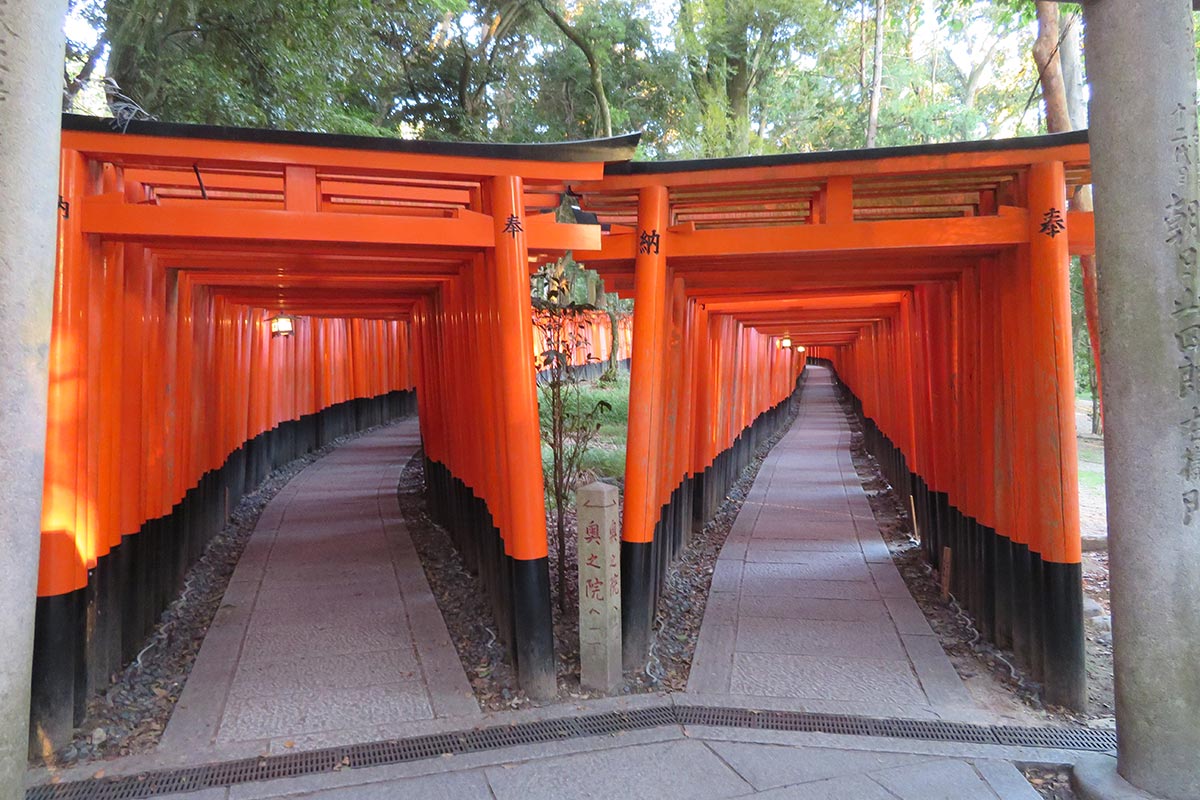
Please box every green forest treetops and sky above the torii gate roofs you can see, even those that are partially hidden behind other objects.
[64,0,1079,158]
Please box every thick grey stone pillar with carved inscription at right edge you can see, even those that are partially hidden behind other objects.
[1084,0,1200,800]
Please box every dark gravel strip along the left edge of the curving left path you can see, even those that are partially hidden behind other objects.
[30,417,408,768]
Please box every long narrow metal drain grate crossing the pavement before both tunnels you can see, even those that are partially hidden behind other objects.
[25,705,1116,800]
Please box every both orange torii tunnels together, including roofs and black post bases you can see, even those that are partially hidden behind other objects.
[32,116,1093,742]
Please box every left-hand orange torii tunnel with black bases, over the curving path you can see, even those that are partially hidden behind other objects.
[32,116,637,748]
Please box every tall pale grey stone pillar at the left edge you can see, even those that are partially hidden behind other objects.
[0,0,67,800]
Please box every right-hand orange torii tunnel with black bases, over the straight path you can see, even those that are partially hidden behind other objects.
[571,134,1093,708]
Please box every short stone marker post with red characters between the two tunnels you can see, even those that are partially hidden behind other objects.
[575,481,622,694]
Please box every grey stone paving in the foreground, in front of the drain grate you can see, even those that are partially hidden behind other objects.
[147,727,1056,800]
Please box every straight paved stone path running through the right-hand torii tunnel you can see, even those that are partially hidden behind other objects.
[688,367,973,717]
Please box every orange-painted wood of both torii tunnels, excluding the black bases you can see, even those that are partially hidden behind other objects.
[40,123,1094,594]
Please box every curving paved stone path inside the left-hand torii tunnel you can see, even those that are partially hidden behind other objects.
[158,419,480,753]
